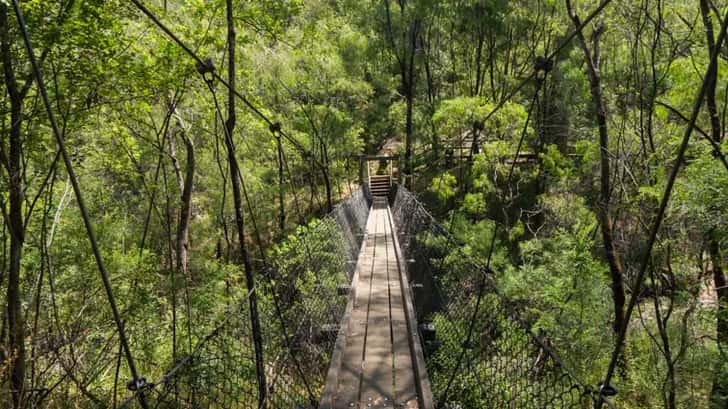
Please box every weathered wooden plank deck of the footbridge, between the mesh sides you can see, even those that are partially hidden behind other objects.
[320,197,432,409]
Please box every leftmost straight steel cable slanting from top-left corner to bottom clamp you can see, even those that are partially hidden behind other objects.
[12,0,147,409]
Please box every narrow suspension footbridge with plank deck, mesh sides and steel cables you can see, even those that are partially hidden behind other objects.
[13,0,708,409]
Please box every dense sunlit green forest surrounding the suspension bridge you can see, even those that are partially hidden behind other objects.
[0,0,728,408]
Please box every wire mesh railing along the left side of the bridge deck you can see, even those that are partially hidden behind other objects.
[118,189,369,409]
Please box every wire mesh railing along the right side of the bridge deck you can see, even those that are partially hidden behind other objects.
[392,187,594,408]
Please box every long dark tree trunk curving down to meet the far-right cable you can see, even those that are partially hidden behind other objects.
[566,0,626,333]
